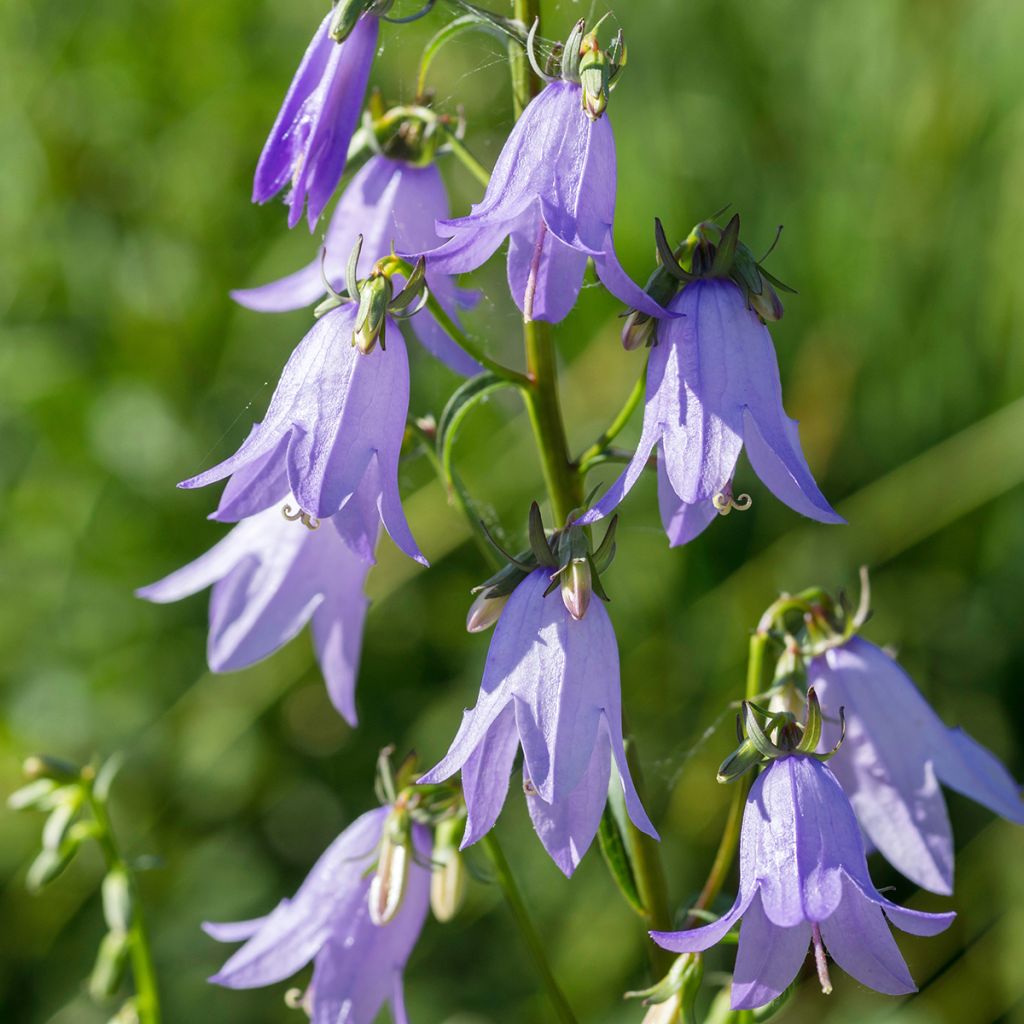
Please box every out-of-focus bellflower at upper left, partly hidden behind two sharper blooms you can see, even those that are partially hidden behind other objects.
[231,155,481,377]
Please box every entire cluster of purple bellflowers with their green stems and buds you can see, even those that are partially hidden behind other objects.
[121,0,1024,1024]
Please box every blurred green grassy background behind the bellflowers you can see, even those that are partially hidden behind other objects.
[0,0,1024,1024]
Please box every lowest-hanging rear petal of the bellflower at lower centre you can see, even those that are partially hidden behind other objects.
[523,740,611,878]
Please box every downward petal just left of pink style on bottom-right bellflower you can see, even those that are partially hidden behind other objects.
[732,897,811,1010]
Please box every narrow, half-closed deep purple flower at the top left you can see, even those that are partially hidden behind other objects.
[253,13,379,230]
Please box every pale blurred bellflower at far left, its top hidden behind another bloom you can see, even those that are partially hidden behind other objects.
[136,483,380,725]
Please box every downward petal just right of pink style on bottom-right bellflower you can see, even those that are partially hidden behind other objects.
[821,883,916,995]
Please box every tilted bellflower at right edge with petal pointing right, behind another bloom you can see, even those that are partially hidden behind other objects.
[808,637,1024,893]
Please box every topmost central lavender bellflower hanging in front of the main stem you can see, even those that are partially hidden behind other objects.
[427,81,665,323]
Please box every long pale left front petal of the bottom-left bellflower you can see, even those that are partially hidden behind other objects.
[210,808,387,988]
